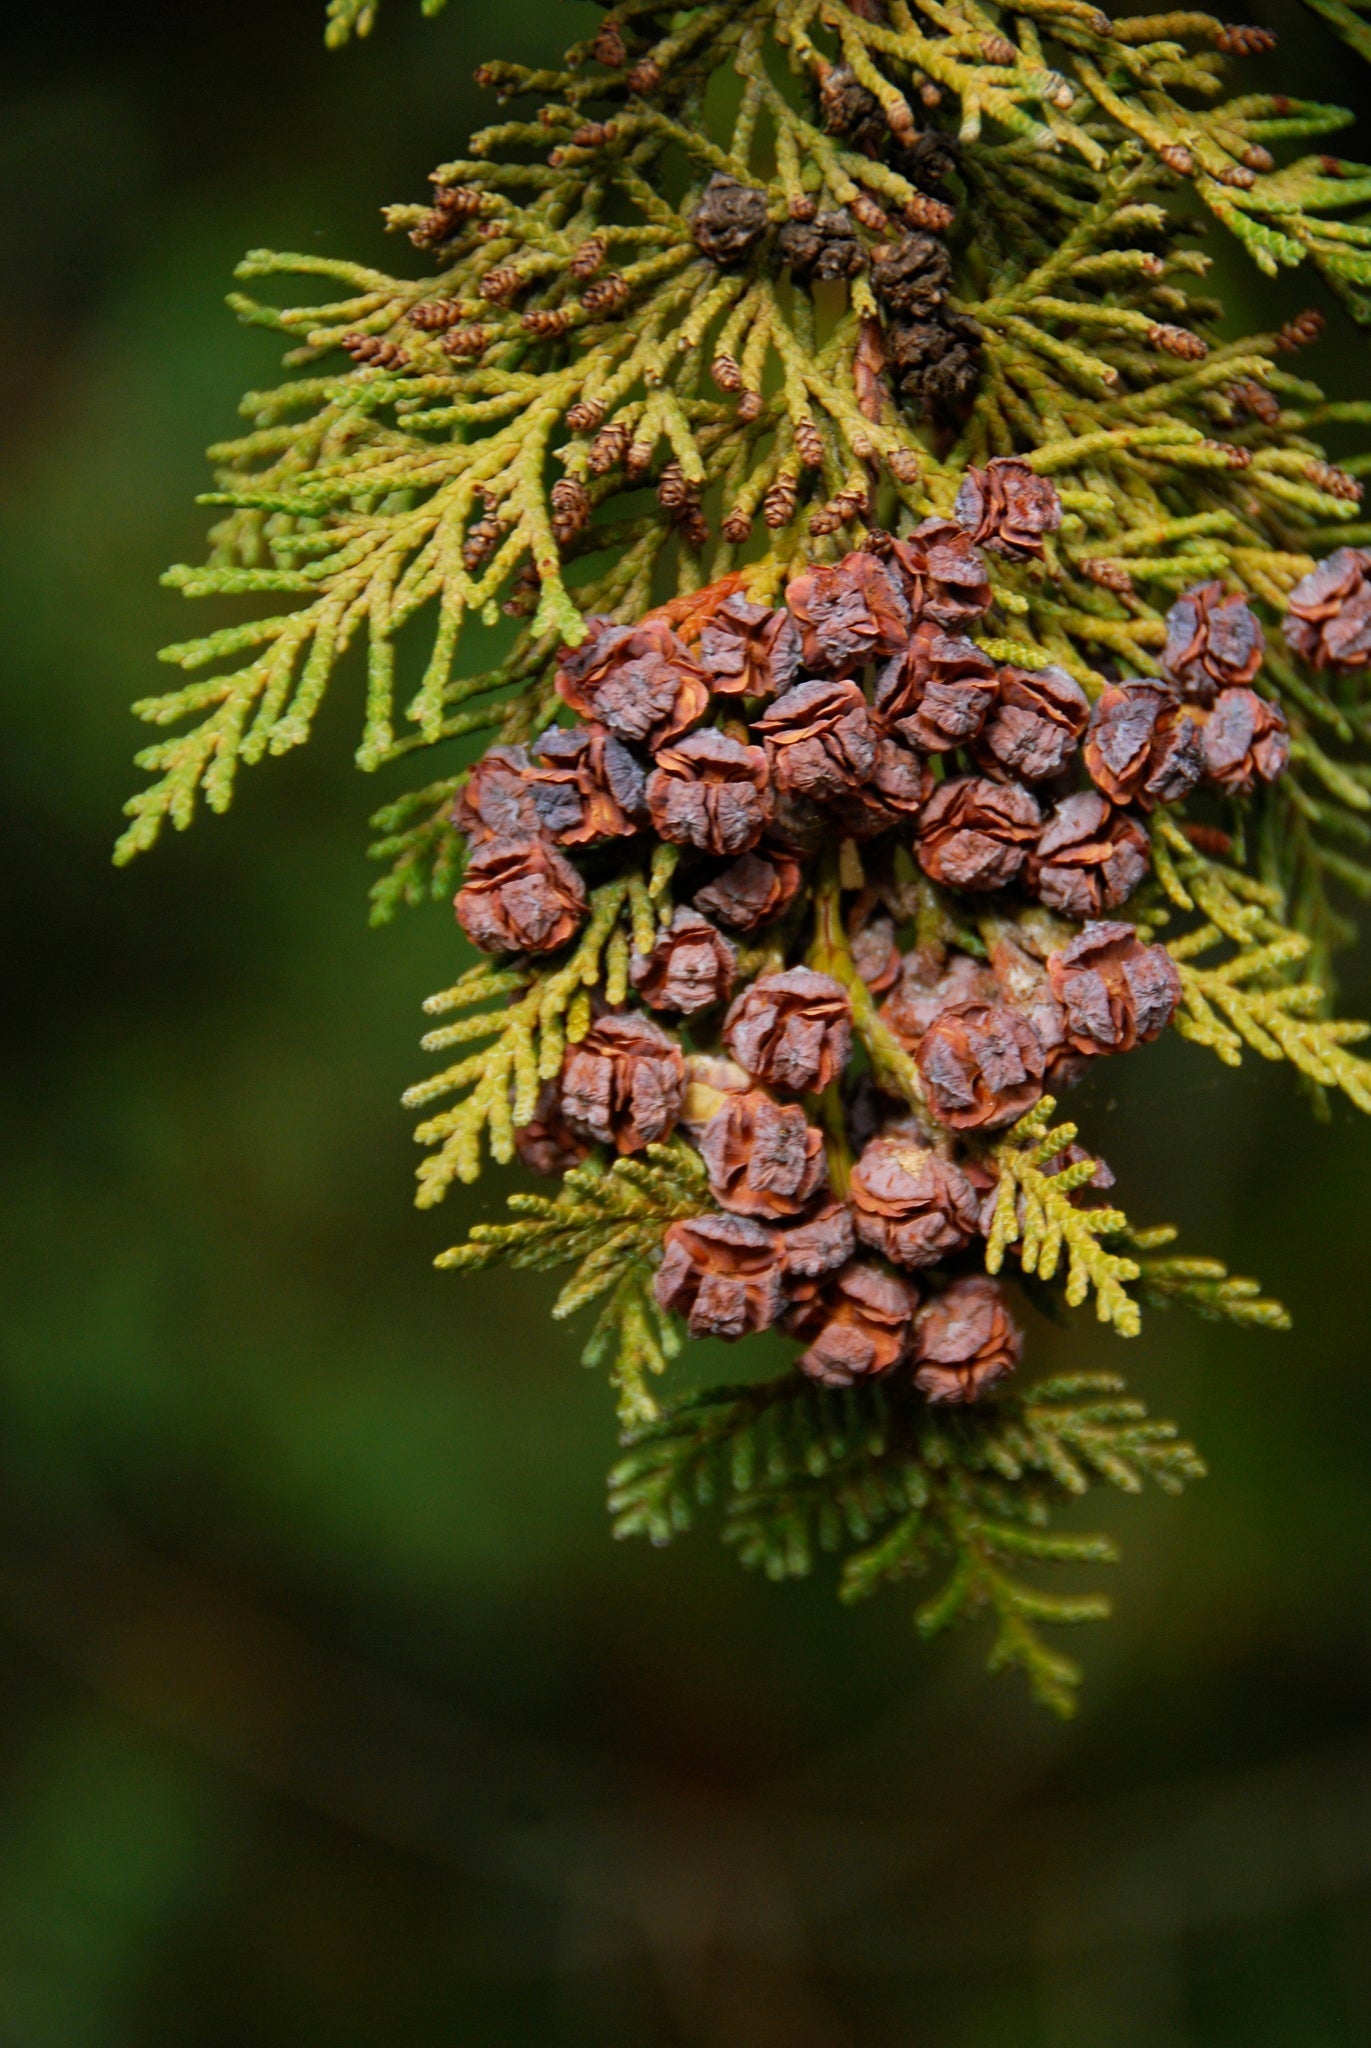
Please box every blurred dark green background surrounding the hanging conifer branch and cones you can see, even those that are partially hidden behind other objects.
[0,0,1371,2048]
